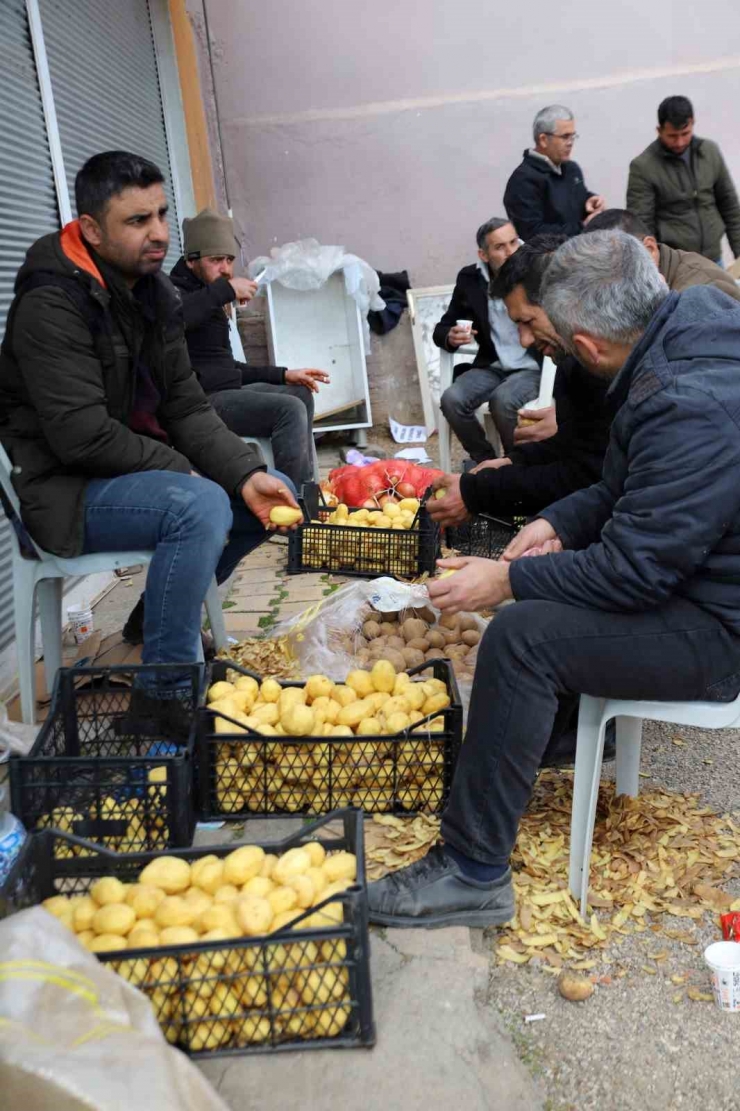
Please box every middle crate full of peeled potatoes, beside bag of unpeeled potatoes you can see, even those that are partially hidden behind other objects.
[196,660,462,821]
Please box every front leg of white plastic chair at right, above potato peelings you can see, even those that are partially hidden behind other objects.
[568,694,606,917]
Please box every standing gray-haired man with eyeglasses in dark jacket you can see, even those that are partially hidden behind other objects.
[503,104,606,240]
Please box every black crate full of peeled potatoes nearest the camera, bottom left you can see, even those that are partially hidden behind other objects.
[0,811,374,1057]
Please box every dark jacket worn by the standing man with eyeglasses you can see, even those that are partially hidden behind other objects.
[503,150,594,240]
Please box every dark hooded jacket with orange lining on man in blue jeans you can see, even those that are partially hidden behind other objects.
[0,221,264,558]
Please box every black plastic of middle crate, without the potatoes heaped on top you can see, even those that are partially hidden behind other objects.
[196,659,462,821]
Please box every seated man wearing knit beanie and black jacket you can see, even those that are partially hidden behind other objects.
[170,208,329,488]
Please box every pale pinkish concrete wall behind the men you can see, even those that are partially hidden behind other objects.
[188,0,740,286]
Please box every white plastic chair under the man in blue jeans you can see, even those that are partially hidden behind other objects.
[0,446,227,725]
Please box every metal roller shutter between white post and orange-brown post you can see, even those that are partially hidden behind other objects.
[39,0,180,270]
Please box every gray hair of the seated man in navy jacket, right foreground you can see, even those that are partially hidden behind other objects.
[542,230,669,352]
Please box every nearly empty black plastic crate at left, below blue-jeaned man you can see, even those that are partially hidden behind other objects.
[9,664,204,852]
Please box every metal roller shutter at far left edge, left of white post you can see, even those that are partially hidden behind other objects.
[0,0,59,651]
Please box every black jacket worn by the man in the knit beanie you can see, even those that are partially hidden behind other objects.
[170,258,286,393]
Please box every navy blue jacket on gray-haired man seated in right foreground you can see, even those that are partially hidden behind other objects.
[511,286,740,633]
